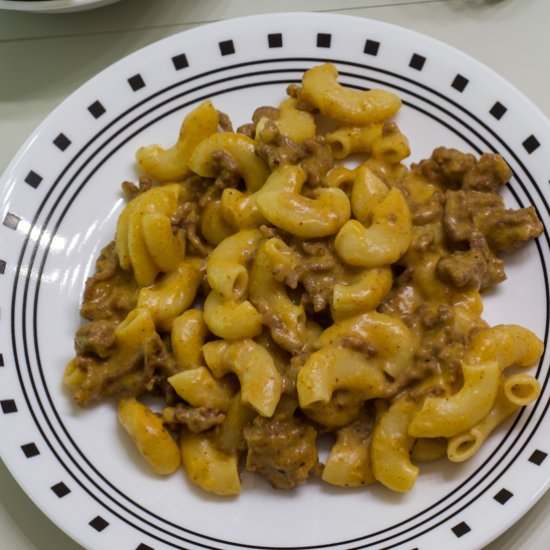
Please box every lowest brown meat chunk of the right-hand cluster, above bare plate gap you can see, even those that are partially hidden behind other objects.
[437,232,506,291]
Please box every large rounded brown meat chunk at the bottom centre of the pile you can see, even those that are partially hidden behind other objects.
[244,414,318,489]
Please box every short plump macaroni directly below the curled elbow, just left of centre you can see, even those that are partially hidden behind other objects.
[204,290,262,340]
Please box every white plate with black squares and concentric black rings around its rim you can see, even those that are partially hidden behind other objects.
[0,9,550,550]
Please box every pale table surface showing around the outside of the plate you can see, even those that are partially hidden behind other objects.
[0,0,550,550]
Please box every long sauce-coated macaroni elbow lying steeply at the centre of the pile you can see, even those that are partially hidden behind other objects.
[250,239,308,351]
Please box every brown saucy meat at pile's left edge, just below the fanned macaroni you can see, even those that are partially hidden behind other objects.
[80,242,138,321]
